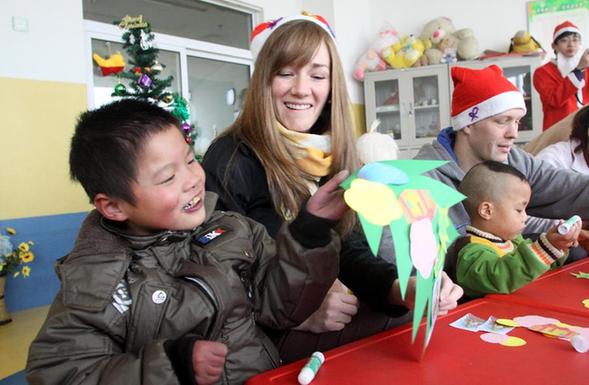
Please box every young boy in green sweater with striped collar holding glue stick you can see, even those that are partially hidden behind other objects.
[449,161,581,298]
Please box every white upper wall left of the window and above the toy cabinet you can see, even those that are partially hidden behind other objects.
[0,0,527,103]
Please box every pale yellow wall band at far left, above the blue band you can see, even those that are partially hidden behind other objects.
[0,77,90,219]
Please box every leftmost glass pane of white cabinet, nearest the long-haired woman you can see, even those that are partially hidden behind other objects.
[374,79,401,139]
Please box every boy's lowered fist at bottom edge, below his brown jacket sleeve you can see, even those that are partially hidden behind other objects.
[192,340,227,385]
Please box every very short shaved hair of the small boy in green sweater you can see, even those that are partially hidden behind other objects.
[458,160,529,217]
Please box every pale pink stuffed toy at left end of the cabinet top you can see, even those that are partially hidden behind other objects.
[353,23,399,81]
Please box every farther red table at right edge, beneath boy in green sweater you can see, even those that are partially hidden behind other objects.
[487,258,589,316]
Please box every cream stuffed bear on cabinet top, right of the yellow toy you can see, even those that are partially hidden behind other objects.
[420,17,479,64]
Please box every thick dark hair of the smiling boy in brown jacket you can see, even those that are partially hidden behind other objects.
[70,99,180,204]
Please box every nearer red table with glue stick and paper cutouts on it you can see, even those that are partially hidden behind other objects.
[246,298,589,385]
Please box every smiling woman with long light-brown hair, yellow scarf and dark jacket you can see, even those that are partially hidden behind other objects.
[203,15,462,362]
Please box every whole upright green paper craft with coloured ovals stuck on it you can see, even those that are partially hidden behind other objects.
[341,160,464,350]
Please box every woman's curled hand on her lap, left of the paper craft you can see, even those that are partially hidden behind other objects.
[294,279,359,333]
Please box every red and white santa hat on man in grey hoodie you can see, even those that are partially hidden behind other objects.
[452,65,526,131]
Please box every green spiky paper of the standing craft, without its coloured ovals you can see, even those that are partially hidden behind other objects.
[341,160,464,350]
